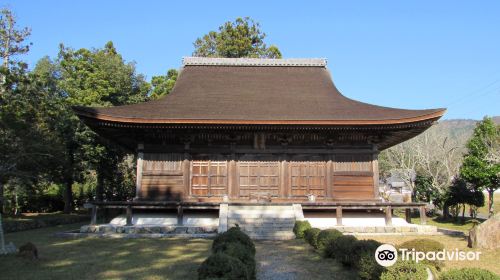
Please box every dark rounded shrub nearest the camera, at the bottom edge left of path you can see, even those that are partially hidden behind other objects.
[198,253,249,279]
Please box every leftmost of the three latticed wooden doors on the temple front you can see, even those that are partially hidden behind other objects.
[191,160,228,196]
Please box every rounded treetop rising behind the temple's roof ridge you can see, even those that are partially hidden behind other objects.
[193,17,281,58]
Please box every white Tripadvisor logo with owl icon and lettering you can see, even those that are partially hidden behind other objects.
[375,244,481,267]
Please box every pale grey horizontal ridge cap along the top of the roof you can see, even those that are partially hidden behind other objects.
[182,57,326,67]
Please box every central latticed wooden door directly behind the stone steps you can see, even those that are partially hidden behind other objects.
[238,161,280,198]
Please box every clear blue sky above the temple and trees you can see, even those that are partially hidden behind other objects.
[4,0,500,119]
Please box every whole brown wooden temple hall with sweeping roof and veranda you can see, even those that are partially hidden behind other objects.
[74,57,445,234]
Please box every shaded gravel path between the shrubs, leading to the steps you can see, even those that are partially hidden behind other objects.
[255,240,356,280]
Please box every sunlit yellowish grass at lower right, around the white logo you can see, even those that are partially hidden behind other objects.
[358,235,500,275]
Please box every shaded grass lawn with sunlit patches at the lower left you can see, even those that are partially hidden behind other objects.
[0,224,212,280]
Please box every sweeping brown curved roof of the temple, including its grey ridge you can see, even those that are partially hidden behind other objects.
[74,58,445,125]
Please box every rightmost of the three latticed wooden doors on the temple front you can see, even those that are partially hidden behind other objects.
[289,161,326,198]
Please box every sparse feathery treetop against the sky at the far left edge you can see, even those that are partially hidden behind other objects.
[0,9,31,68]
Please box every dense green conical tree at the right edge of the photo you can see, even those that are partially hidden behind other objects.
[460,117,500,217]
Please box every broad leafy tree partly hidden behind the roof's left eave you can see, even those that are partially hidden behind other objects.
[58,42,150,207]
